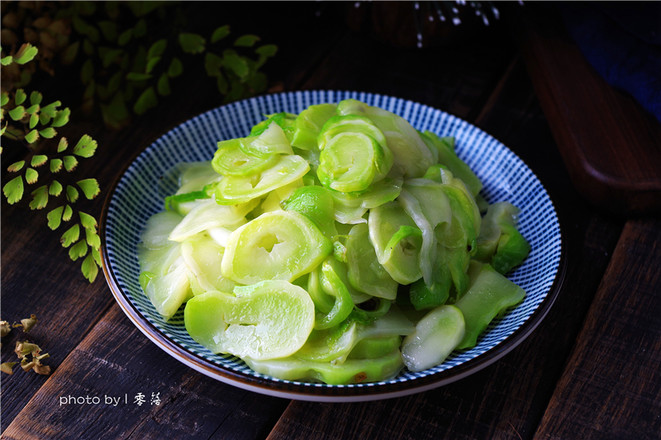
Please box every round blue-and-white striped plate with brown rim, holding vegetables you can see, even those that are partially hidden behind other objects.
[101,91,562,402]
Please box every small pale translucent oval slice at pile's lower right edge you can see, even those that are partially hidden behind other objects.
[402,305,466,371]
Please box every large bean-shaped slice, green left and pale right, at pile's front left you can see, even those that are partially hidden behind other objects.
[184,281,314,360]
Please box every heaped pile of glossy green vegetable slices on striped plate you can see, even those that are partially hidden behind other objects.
[139,99,530,384]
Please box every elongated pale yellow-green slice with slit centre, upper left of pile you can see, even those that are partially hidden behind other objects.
[215,155,310,205]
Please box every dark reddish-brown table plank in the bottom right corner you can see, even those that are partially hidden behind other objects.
[536,219,661,440]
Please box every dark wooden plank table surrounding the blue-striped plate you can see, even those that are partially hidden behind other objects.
[2,2,661,440]
